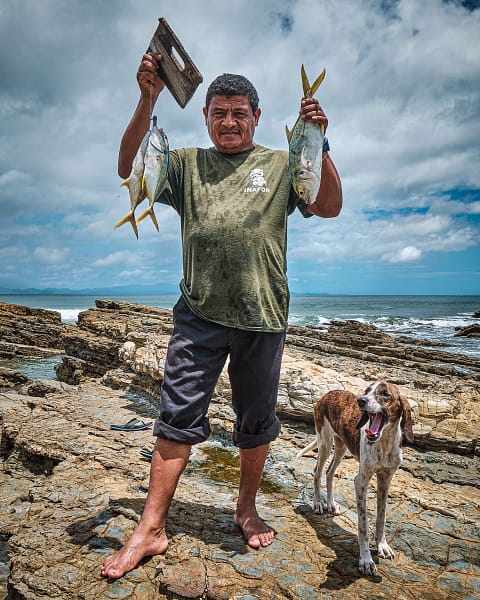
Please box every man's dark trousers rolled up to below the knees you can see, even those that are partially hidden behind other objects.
[153,298,285,448]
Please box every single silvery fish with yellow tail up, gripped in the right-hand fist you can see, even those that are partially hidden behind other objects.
[285,65,325,205]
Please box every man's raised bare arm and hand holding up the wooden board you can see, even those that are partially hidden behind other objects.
[118,53,165,179]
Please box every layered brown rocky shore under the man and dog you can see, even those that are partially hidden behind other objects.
[0,300,480,600]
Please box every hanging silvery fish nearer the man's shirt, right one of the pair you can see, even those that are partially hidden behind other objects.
[137,117,169,231]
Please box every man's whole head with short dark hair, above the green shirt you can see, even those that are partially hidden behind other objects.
[203,73,260,154]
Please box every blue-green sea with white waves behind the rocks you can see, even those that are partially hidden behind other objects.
[0,294,480,358]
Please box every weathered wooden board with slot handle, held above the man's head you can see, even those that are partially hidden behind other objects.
[147,17,203,108]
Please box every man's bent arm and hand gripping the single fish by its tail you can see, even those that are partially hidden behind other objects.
[300,98,342,217]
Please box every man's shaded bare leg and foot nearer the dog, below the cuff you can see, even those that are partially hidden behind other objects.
[234,444,275,548]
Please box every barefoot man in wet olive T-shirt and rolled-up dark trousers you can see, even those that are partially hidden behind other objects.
[102,54,342,578]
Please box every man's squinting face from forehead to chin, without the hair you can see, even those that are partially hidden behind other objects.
[203,96,260,154]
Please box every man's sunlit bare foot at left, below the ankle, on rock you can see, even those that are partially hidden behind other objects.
[102,525,168,579]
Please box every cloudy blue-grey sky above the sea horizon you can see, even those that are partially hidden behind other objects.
[0,0,480,295]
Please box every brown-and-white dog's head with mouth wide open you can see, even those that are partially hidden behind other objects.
[357,381,413,443]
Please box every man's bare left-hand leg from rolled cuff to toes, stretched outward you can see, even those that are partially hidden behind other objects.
[102,438,190,579]
